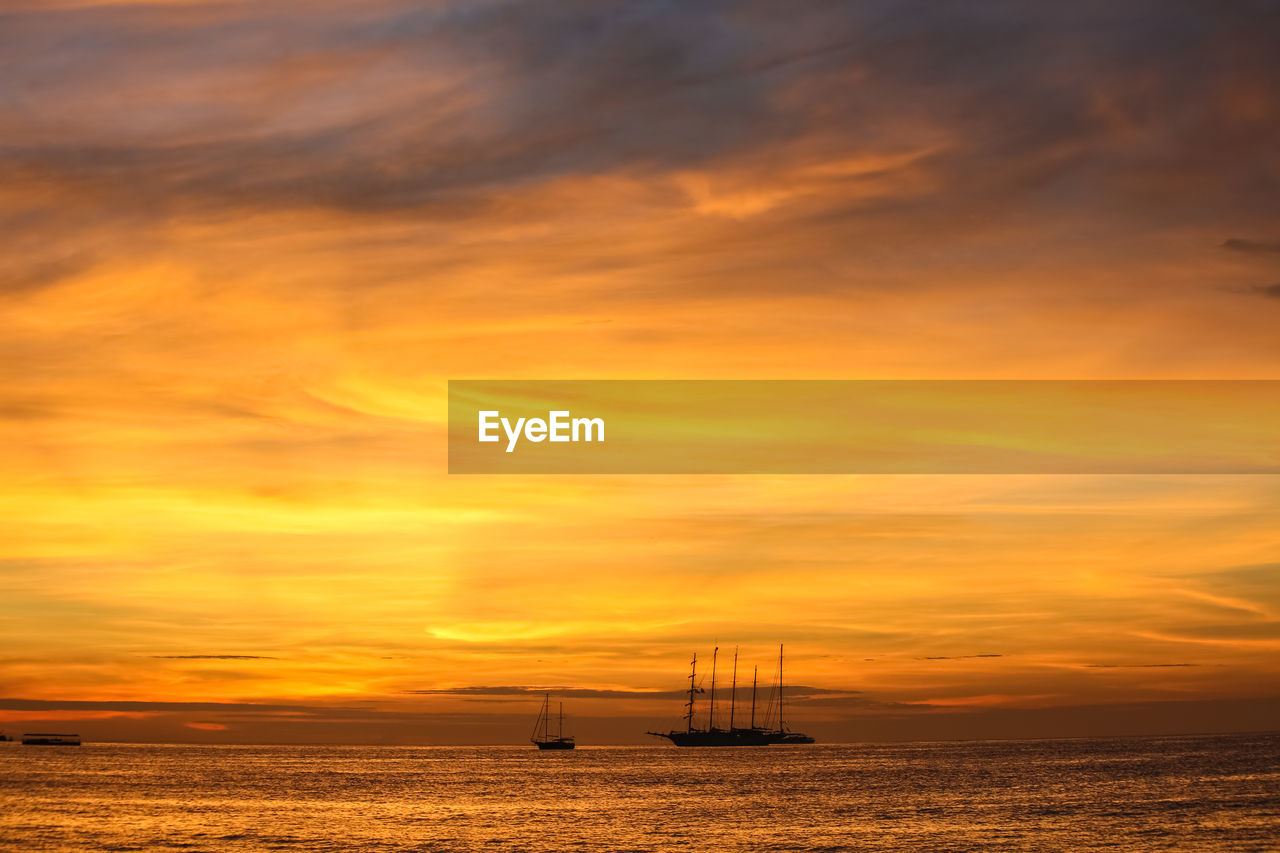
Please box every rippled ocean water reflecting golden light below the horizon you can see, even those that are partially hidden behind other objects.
[0,735,1280,852]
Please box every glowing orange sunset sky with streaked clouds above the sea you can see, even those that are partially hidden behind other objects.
[0,0,1280,743]
